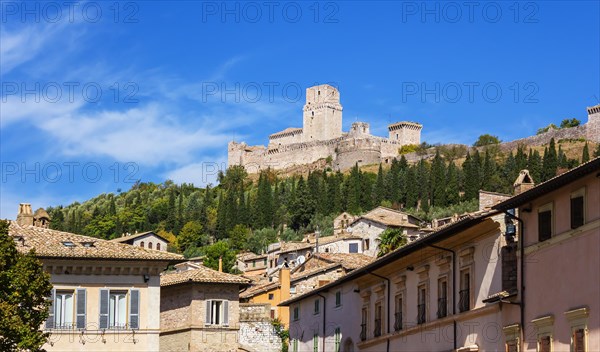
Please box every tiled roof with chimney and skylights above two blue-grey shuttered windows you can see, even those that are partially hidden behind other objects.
[8,221,183,261]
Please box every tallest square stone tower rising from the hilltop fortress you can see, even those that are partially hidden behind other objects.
[302,84,342,142]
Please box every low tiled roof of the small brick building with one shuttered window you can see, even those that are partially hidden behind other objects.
[160,265,250,286]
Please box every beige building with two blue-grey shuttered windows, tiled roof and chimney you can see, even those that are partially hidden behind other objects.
[9,204,183,352]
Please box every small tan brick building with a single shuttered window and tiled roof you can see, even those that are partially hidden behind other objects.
[160,266,249,352]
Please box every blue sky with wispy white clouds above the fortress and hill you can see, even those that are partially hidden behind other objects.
[0,1,600,218]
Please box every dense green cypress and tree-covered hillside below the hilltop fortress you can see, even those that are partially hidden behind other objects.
[48,140,590,270]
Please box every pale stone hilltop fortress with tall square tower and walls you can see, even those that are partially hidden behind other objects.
[227,84,423,173]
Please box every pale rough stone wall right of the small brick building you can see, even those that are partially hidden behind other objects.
[239,303,281,352]
